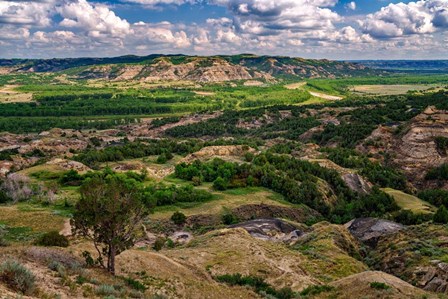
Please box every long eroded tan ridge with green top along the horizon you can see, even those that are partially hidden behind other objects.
[0,55,378,82]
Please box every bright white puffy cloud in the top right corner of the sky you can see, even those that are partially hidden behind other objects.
[360,0,448,39]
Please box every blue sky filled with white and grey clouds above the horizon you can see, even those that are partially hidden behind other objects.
[0,0,448,60]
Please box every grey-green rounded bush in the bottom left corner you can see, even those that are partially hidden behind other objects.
[0,260,36,295]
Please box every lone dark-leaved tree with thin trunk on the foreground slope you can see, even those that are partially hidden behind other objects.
[71,174,147,274]
